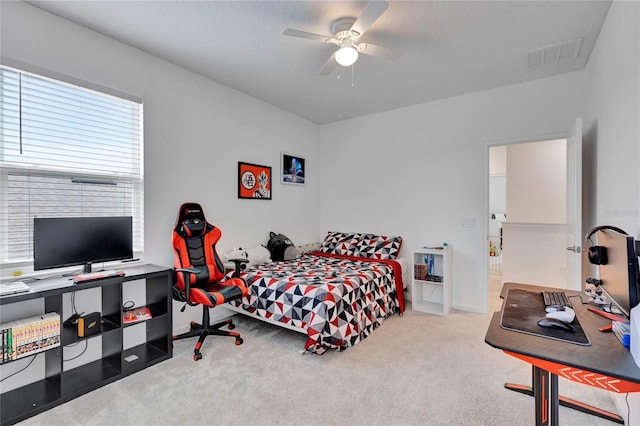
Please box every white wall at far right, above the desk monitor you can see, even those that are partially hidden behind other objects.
[583,1,640,424]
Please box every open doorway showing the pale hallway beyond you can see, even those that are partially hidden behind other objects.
[487,138,567,298]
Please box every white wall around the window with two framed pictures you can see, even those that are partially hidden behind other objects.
[0,2,320,328]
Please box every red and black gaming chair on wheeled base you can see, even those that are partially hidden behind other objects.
[172,203,247,361]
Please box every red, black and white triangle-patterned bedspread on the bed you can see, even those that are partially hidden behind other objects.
[231,254,404,354]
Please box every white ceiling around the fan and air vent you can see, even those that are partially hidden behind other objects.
[28,0,610,124]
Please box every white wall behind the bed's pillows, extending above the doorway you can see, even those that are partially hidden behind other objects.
[320,72,584,312]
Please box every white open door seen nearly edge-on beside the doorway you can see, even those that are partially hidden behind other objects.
[566,118,582,291]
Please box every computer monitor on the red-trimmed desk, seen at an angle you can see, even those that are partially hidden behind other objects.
[598,230,640,317]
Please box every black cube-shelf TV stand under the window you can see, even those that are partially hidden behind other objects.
[0,265,173,426]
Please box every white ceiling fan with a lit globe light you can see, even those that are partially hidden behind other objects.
[283,0,400,75]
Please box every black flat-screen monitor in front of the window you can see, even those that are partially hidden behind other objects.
[33,216,133,273]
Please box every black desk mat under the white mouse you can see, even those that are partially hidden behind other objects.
[500,289,591,346]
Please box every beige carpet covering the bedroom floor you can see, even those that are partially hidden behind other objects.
[23,277,615,426]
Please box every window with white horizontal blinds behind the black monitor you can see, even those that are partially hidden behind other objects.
[0,66,144,267]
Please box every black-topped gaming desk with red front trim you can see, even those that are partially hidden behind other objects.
[485,283,640,425]
